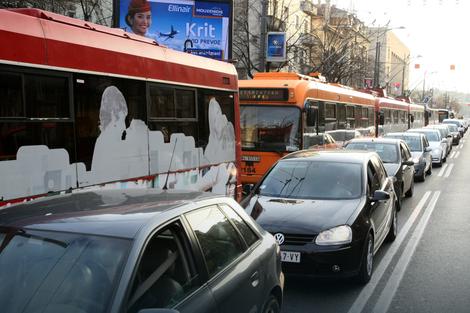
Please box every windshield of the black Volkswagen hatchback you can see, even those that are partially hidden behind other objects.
[259,160,362,199]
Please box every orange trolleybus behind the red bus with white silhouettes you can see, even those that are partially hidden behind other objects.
[239,72,375,184]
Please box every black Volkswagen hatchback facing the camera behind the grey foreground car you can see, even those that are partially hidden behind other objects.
[242,150,397,283]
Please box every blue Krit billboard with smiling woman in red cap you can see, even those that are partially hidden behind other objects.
[117,0,231,60]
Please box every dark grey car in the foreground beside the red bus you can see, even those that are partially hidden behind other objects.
[0,190,283,313]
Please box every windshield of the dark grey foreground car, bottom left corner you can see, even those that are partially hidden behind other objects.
[0,228,131,313]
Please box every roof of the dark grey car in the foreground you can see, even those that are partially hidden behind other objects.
[0,189,222,238]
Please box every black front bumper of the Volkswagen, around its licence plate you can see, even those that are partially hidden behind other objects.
[281,240,364,278]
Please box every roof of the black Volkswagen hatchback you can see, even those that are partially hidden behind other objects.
[281,150,376,163]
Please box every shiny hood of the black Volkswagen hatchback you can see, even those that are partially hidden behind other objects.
[245,195,365,234]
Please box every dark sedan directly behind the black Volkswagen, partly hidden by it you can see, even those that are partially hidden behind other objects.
[345,138,415,211]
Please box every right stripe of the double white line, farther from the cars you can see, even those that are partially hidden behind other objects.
[372,191,441,313]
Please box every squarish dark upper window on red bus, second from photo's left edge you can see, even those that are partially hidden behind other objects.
[24,74,71,118]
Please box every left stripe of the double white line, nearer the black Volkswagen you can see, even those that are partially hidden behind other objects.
[348,191,431,313]
